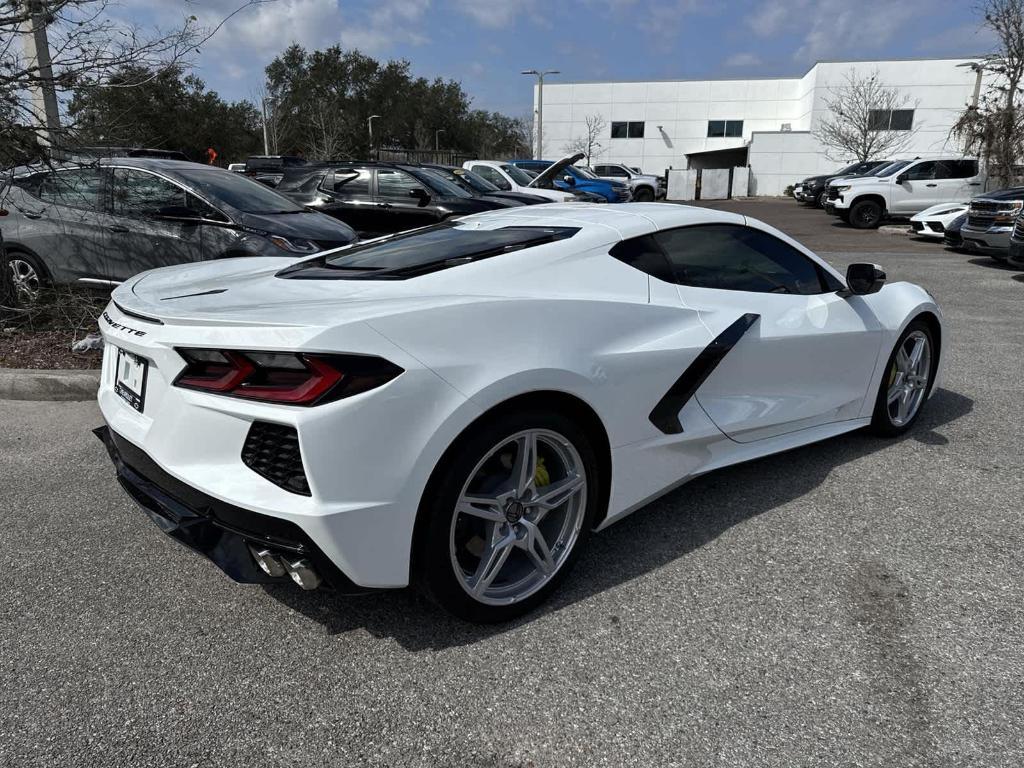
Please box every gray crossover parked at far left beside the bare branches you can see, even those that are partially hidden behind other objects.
[0,158,356,300]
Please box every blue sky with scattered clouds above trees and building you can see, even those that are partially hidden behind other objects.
[118,0,992,116]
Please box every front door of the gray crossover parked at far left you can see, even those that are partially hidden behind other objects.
[108,168,204,281]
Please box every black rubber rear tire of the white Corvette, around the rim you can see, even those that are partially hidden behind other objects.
[413,408,600,624]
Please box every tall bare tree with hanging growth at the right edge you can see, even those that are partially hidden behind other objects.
[950,0,1024,186]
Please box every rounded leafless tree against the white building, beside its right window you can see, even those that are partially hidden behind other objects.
[811,69,918,161]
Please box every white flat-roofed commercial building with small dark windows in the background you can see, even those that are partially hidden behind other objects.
[534,58,977,196]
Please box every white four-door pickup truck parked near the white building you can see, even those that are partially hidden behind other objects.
[825,158,985,229]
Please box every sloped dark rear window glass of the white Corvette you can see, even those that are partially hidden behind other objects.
[278,222,579,280]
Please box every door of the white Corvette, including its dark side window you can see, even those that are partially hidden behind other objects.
[653,224,882,442]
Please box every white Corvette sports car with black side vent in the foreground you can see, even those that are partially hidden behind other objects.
[96,203,944,621]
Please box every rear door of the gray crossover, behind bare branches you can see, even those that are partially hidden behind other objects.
[38,167,111,282]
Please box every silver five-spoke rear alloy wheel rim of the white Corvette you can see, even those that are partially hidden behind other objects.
[450,429,587,605]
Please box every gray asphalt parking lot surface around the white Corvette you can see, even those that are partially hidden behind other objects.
[0,201,1024,768]
